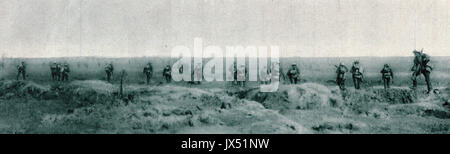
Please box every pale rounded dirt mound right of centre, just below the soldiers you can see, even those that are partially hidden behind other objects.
[246,83,342,110]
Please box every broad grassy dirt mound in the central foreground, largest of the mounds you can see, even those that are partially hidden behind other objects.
[41,85,308,133]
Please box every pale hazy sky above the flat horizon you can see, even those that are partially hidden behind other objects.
[0,0,450,57]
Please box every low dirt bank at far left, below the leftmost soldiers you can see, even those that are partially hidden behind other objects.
[0,80,116,106]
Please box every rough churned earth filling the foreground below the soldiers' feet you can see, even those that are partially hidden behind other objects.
[0,80,450,134]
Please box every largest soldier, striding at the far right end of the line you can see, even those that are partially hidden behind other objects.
[411,49,433,93]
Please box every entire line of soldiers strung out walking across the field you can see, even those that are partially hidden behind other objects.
[16,49,433,93]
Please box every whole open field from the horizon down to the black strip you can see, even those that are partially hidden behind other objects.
[0,57,450,134]
